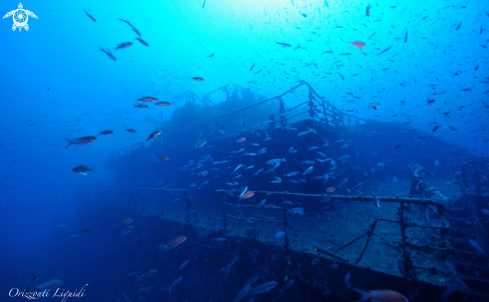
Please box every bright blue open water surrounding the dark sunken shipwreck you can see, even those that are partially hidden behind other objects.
[0,0,489,301]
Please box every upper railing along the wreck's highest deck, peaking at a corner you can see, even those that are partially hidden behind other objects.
[107,82,366,163]
